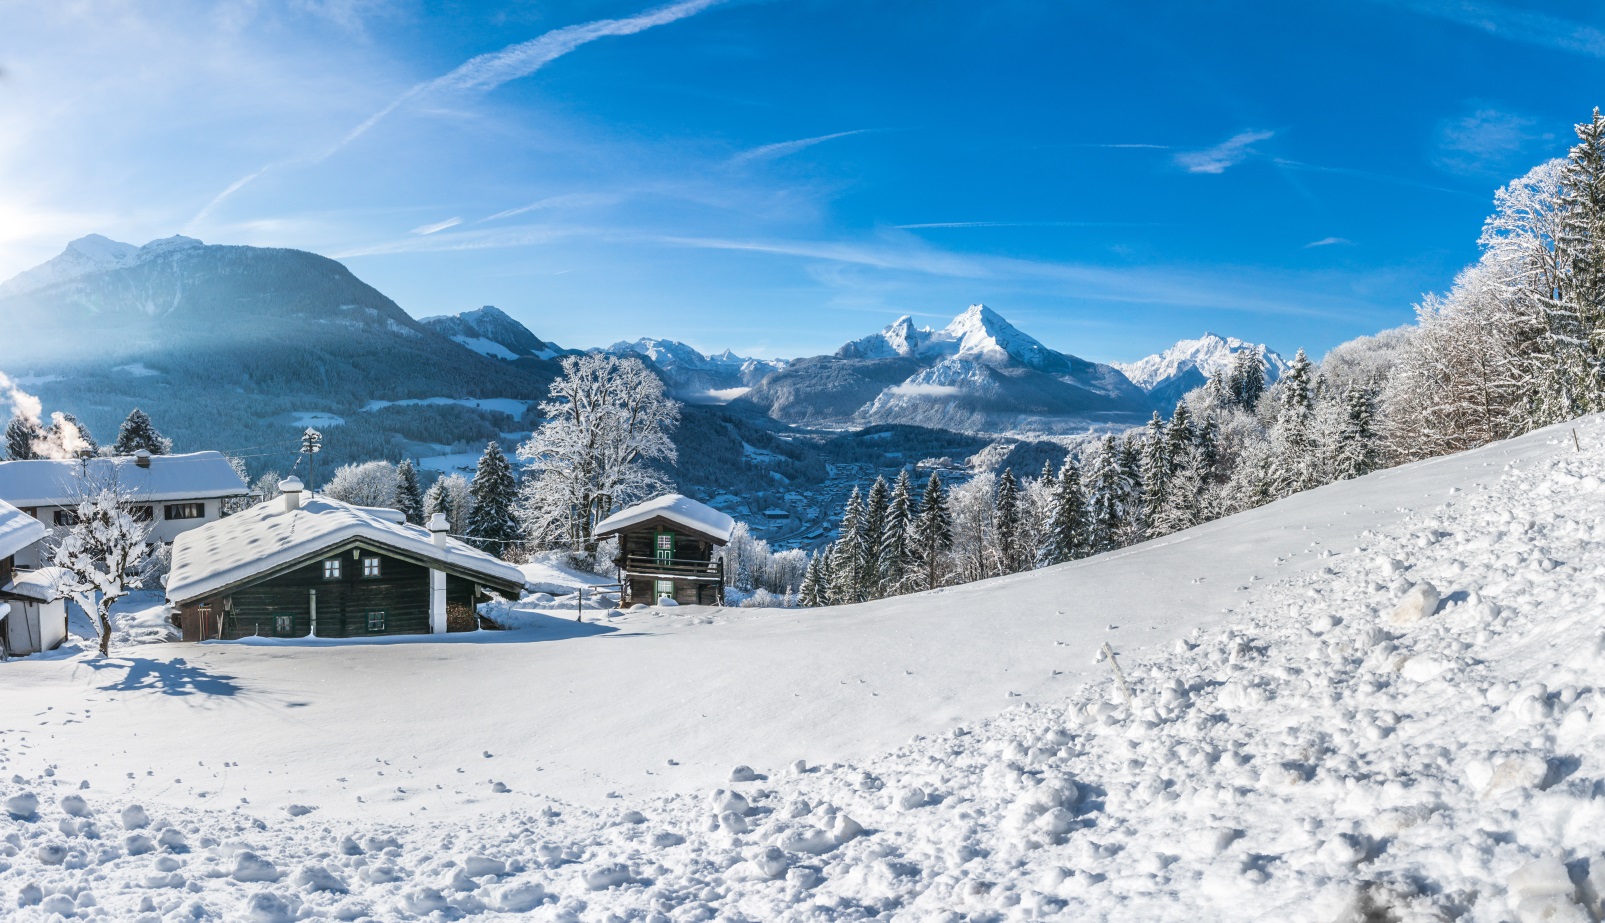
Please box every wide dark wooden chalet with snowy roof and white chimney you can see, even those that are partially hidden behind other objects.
[167,478,523,640]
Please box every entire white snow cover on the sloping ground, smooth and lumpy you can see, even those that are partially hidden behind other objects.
[0,419,1605,923]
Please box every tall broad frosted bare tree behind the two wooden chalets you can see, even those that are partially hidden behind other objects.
[517,353,681,551]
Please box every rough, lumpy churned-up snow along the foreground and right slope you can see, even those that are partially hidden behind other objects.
[0,417,1605,923]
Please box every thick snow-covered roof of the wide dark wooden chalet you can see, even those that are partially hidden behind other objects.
[167,496,523,604]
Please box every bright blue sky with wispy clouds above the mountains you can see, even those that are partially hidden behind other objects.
[0,0,1605,361]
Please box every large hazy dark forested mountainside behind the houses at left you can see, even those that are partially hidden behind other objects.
[0,238,555,470]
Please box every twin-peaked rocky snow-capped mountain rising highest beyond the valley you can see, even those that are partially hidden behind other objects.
[742,305,1149,432]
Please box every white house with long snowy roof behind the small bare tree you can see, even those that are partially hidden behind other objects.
[0,451,250,567]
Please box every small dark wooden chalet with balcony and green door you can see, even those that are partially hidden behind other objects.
[595,493,735,605]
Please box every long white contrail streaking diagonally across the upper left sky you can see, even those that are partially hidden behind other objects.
[189,0,727,225]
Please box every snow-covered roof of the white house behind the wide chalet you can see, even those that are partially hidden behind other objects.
[0,451,250,506]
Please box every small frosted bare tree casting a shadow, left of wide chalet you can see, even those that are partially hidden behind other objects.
[51,464,151,657]
